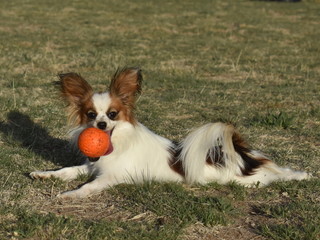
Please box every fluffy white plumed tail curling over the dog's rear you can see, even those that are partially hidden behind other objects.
[180,123,238,183]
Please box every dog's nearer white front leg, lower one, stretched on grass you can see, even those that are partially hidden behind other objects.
[57,176,114,199]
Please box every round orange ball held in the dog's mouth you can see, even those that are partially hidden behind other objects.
[78,127,110,158]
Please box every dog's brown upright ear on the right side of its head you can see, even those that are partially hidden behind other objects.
[109,68,142,106]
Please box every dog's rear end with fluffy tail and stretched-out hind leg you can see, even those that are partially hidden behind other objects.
[180,123,306,185]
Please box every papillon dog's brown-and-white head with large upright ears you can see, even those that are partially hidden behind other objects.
[59,68,142,131]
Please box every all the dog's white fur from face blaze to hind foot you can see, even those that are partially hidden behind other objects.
[30,81,308,198]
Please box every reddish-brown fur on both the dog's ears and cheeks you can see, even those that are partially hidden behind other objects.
[59,68,142,125]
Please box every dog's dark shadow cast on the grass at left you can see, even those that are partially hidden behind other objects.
[0,111,83,170]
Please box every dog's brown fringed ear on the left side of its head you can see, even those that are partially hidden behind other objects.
[57,72,93,106]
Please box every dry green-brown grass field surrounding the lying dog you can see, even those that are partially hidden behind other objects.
[0,0,320,239]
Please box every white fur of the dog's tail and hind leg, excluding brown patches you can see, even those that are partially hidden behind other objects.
[181,123,308,187]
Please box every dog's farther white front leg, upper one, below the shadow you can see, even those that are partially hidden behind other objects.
[30,162,92,181]
